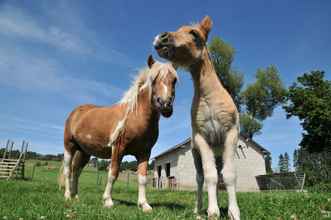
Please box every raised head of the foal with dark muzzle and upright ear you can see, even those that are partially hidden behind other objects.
[153,16,212,67]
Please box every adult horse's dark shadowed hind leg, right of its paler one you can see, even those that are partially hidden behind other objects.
[71,150,90,199]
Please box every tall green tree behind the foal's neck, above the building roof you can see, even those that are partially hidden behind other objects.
[209,37,286,139]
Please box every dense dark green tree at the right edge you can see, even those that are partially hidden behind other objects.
[284,71,331,152]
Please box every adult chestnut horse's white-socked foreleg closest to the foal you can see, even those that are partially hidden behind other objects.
[138,157,152,212]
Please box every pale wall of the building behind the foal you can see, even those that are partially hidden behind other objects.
[154,140,266,191]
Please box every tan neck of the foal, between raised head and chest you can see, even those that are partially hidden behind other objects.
[190,48,224,97]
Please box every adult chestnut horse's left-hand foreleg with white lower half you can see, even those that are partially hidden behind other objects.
[103,153,121,208]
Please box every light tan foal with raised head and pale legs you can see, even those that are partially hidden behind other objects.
[154,17,240,220]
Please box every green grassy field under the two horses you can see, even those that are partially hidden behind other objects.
[0,160,331,220]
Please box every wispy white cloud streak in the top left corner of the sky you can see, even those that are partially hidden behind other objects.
[0,1,132,66]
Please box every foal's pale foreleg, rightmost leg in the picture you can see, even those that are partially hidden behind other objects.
[222,128,240,220]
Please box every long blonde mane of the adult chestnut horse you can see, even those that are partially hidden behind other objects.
[108,62,178,150]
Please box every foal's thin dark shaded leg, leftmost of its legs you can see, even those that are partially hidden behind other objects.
[192,147,204,214]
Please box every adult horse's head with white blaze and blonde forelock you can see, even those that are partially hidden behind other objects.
[147,56,177,118]
